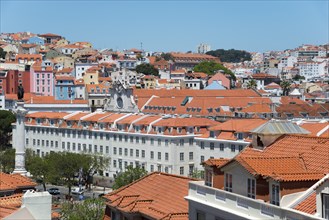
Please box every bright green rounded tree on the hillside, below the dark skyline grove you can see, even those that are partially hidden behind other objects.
[193,61,236,80]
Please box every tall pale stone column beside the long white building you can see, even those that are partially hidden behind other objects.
[13,101,28,176]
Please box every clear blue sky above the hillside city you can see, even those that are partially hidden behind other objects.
[0,0,329,52]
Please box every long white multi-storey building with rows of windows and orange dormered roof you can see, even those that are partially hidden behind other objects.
[13,111,264,177]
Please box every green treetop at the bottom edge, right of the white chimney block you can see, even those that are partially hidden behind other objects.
[60,198,105,220]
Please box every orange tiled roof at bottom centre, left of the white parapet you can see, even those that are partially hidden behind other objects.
[104,172,193,219]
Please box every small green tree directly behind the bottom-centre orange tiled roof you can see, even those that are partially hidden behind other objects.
[113,166,147,189]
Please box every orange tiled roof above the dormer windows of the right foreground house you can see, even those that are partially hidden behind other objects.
[220,135,329,181]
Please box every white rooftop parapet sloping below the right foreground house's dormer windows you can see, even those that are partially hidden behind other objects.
[185,181,321,220]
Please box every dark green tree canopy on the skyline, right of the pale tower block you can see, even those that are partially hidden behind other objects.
[206,49,251,63]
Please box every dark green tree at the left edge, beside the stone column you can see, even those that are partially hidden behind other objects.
[0,110,16,150]
